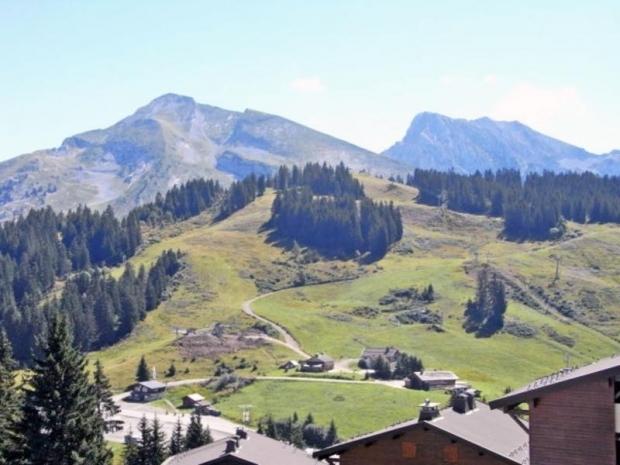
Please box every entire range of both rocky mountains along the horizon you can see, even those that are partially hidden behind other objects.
[0,94,620,220]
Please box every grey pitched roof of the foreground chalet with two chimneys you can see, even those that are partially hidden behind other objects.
[314,402,529,465]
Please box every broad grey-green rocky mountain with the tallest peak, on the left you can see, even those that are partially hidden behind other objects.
[0,93,400,219]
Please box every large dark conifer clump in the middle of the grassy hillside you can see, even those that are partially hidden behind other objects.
[269,164,403,259]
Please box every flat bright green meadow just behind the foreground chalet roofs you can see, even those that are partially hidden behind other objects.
[160,381,447,438]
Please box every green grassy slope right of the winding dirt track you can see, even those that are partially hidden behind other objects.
[255,177,620,396]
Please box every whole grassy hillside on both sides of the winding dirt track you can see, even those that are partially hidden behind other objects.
[92,172,620,422]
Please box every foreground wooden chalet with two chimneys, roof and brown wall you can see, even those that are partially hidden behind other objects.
[314,394,528,465]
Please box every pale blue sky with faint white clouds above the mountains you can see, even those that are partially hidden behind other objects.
[0,0,620,159]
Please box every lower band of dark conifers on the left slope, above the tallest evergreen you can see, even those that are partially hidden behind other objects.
[2,250,181,363]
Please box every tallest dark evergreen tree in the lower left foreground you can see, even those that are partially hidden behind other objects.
[20,314,112,465]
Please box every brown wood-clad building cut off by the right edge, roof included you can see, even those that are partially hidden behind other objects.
[490,356,620,465]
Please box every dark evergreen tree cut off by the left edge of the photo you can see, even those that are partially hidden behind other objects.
[0,329,21,465]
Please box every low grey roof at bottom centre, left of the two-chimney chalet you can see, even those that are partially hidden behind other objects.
[163,431,319,465]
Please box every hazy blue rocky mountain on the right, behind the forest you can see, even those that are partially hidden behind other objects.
[383,112,620,174]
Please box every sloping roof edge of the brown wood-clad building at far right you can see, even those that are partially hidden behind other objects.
[489,355,620,408]
